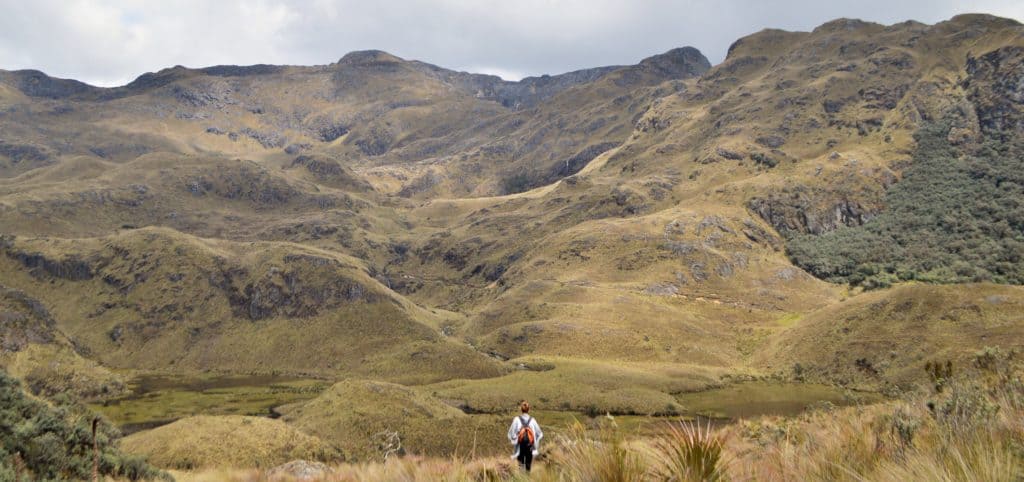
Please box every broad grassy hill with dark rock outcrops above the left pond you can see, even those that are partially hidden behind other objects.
[0,228,502,382]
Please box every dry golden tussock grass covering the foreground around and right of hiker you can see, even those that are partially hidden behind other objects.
[179,350,1024,482]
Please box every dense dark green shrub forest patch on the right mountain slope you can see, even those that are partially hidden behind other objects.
[786,123,1024,289]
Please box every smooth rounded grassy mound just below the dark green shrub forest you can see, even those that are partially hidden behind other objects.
[757,283,1024,389]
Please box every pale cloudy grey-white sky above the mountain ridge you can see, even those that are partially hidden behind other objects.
[0,0,1024,86]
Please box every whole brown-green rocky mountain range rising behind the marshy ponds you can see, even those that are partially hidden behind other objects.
[0,15,1024,464]
